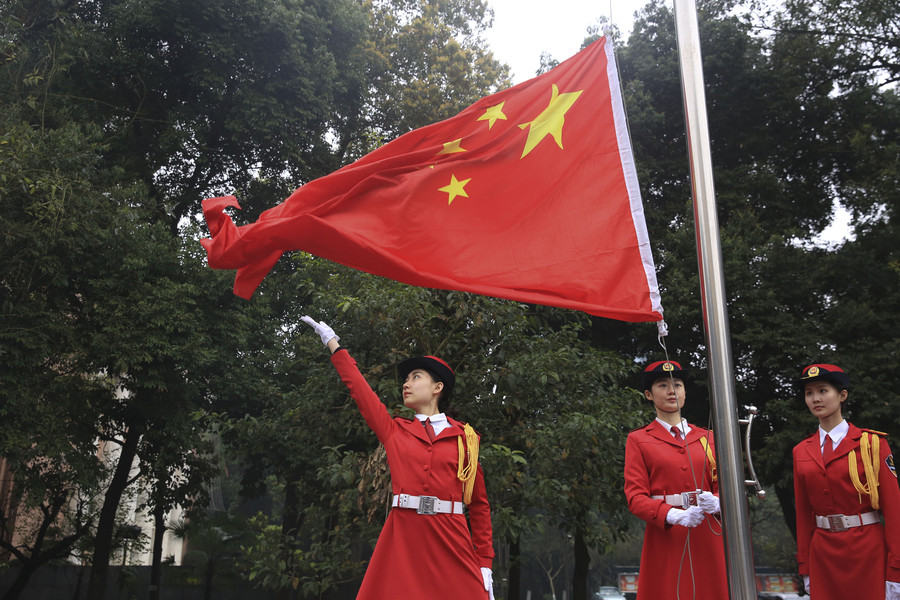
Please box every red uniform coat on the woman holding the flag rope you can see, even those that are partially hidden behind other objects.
[625,420,728,600]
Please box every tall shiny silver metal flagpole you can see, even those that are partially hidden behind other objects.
[674,0,757,600]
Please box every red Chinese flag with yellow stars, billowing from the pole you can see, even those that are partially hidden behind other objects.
[202,38,662,321]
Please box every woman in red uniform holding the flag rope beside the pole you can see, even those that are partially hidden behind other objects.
[625,361,728,600]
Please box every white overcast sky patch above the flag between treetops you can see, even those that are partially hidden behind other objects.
[486,0,646,83]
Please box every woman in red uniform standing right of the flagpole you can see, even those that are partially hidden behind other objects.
[794,364,900,600]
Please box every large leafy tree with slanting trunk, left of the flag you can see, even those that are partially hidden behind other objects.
[3,1,372,597]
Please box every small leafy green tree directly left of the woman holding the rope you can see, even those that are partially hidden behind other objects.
[523,342,645,600]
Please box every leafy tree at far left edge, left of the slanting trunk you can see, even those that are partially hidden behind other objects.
[0,107,116,599]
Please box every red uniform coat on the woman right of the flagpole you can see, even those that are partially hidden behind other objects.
[794,424,900,600]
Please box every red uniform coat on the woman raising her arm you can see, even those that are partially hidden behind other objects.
[331,350,494,600]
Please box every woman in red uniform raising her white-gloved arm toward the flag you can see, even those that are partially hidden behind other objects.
[302,316,494,600]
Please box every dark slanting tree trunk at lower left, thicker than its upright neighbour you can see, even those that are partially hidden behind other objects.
[87,428,141,600]
